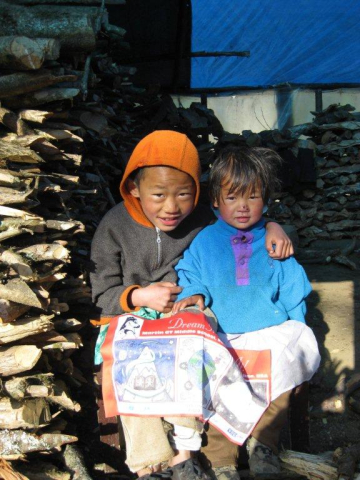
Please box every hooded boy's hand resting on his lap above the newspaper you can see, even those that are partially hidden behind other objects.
[130,282,182,313]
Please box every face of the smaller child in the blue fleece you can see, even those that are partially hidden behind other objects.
[214,183,264,230]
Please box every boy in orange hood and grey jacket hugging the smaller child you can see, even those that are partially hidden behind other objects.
[91,131,293,480]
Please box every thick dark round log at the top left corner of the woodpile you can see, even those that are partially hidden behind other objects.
[0,1,95,54]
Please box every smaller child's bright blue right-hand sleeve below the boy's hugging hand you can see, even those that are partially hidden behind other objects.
[279,258,312,323]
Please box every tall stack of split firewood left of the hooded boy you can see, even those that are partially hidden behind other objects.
[0,0,222,479]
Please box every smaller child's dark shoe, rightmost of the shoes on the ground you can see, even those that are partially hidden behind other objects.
[246,437,281,475]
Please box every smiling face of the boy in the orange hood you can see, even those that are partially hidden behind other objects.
[129,167,196,232]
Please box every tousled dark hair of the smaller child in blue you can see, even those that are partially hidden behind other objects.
[209,146,282,203]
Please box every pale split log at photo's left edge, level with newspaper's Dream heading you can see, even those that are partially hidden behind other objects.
[0,315,54,345]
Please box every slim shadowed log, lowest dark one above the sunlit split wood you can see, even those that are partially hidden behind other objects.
[3,88,80,108]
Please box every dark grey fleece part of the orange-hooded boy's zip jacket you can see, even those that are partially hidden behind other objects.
[90,203,214,317]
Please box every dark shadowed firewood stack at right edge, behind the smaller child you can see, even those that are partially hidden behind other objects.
[271,105,360,246]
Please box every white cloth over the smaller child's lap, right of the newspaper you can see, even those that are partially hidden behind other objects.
[218,320,320,400]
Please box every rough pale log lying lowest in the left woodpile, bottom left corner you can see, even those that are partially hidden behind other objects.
[0,430,77,460]
